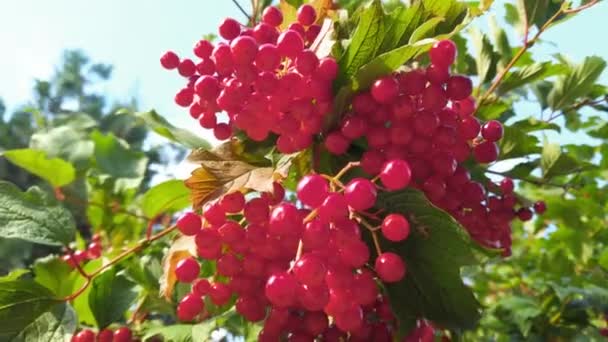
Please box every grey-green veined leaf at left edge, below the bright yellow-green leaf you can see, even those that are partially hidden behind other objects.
[0,181,76,245]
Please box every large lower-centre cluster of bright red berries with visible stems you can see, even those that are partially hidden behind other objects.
[175,160,410,341]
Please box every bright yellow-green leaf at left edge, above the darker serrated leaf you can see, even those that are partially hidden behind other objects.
[2,148,76,188]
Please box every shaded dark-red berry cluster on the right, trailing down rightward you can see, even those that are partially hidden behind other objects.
[325,40,544,254]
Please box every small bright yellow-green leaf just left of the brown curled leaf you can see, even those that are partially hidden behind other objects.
[141,180,190,217]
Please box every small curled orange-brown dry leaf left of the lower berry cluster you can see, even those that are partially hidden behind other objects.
[159,236,196,300]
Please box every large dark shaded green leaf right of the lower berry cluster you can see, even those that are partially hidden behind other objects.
[377,189,480,333]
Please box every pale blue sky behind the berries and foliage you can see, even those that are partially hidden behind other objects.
[0,0,608,147]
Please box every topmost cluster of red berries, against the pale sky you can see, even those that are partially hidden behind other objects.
[161,4,338,153]
